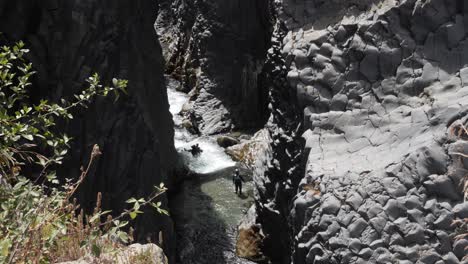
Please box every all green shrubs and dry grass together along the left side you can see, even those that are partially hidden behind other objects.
[0,42,167,263]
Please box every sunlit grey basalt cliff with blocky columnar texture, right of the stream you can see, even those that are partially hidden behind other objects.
[252,0,468,263]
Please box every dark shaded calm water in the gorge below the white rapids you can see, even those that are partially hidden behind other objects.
[172,168,251,264]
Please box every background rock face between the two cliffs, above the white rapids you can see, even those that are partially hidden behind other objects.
[156,0,271,134]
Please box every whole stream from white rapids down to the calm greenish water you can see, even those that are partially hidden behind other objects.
[167,78,253,264]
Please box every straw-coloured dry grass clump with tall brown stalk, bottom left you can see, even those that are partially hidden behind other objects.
[0,146,131,263]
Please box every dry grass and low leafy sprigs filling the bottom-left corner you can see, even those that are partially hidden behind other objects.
[0,145,165,264]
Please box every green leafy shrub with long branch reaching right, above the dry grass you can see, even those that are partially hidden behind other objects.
[0,42,127,184]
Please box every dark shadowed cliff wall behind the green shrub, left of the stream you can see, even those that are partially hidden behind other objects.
[0,0,176,257]
